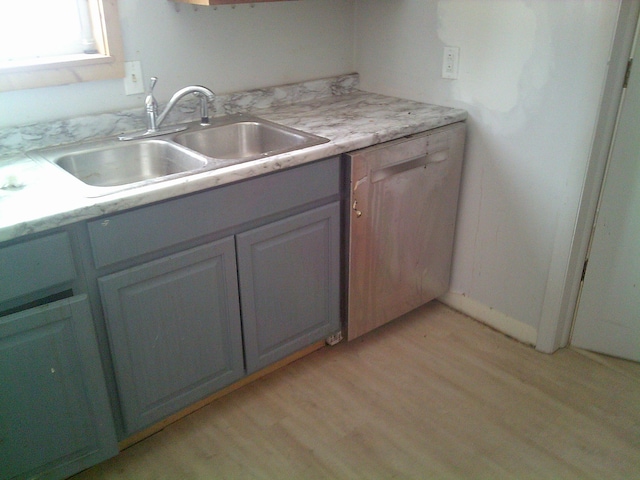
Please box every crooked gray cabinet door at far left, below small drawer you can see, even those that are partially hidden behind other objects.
[0,295,118,480]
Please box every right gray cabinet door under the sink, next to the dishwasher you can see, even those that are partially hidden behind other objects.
[237,202,340,373]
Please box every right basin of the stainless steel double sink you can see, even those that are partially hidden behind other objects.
[173,118,329,161]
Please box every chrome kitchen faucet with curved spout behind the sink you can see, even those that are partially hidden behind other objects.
[118,77,216,140]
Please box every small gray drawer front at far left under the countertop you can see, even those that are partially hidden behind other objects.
[0,232,76,303]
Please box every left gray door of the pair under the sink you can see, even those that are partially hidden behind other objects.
[98,237,244,435]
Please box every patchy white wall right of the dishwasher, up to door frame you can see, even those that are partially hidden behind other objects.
[355,0,619,342]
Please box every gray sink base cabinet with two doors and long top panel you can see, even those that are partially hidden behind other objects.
[85,157,340,438]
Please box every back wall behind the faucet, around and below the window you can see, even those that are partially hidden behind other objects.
[0,0,353,128]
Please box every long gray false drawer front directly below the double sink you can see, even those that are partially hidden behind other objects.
[88,157,340,268]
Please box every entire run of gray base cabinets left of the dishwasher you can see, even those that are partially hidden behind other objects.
[0,157,340,472]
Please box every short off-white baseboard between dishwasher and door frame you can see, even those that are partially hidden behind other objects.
[438,292,538,346]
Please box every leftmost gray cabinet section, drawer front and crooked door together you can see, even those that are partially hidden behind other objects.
[0,230,118,480]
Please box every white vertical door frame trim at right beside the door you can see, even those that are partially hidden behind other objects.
[536,0,640,353]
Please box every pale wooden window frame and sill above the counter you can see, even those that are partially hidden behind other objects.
[0,0,125,92]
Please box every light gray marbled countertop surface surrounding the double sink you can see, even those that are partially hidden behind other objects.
[0,80,467,241]
